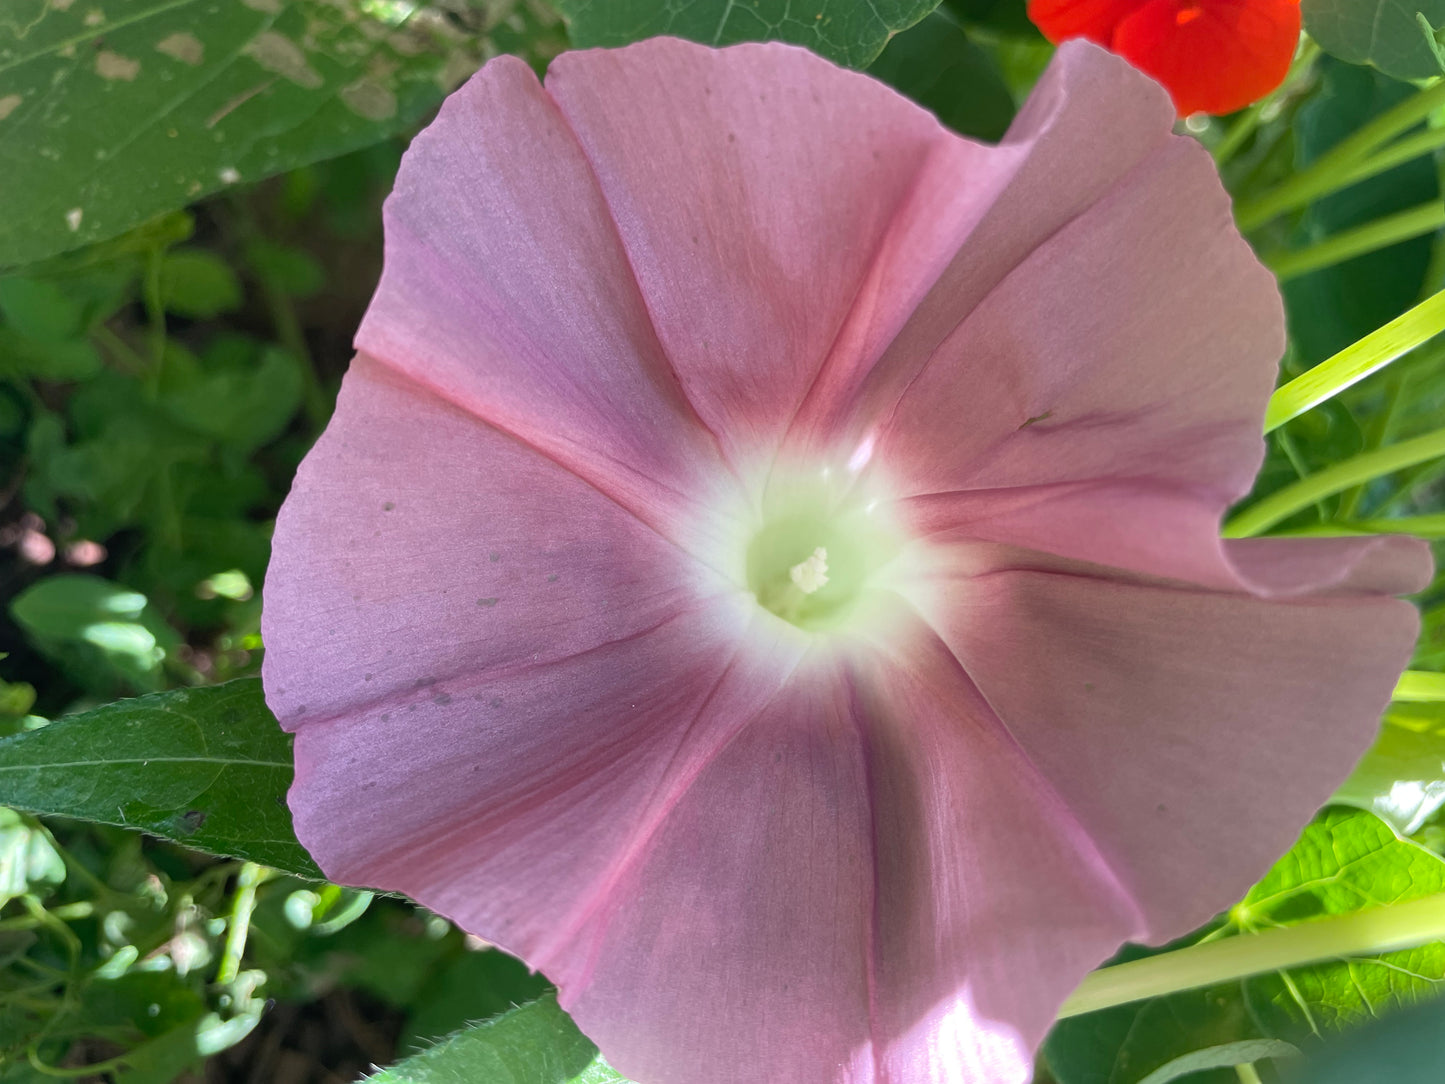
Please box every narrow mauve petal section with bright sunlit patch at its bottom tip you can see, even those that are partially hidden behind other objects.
[860,629,1144,1084]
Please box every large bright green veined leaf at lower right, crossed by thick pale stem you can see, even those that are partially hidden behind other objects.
[1045,808,1445,1084]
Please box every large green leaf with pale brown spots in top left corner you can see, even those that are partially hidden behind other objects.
[0,0,546,266]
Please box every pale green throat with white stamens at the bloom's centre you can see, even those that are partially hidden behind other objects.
[747,483,899,632]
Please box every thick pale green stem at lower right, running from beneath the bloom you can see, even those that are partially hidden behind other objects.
[1059,893,1445,1019]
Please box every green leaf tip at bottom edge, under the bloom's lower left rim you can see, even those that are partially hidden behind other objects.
[368,994,627,1084]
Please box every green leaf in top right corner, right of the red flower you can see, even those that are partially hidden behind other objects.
[1299,0,1445,79]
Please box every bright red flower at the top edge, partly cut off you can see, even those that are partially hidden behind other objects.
[1029,0,1299,116]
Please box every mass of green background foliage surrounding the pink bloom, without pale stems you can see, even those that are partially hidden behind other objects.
[0,0,1445,1084]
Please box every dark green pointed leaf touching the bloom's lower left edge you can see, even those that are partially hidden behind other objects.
[0,678,321,879]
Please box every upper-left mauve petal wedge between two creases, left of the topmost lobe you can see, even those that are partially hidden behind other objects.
[357,56,736,543]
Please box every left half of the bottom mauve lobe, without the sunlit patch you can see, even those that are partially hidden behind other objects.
[555,668,874,1084]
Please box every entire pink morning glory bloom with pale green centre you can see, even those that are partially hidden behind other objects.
[264,40,1429,1084]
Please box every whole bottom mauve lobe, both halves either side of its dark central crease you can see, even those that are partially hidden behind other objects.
[558,627,1142,1084]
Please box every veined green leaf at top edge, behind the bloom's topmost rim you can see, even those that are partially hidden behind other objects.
[558,0,939,68]
